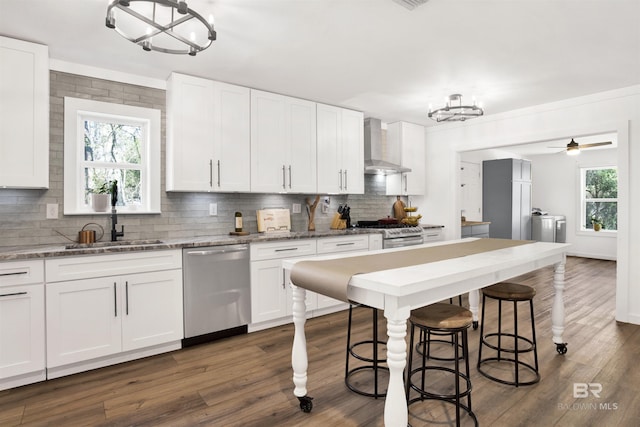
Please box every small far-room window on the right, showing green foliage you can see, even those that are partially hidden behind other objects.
[580,167,618,231]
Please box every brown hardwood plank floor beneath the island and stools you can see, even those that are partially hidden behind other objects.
[0,257,640,427]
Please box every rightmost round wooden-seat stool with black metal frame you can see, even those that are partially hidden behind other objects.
[478,282,540,387]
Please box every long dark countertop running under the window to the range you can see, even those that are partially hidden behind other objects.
[0,229,382,262]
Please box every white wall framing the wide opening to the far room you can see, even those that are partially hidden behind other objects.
[422,86,640,324]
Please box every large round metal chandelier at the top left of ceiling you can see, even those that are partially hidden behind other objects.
[105,0,216,56]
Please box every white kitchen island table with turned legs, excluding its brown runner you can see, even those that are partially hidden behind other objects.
[283,239,570,427]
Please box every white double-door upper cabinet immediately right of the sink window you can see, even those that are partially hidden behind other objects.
[167,73,250,192]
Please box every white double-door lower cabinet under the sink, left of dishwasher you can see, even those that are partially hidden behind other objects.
[46,251,184,378]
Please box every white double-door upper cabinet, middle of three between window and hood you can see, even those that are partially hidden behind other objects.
[251,90,317,193]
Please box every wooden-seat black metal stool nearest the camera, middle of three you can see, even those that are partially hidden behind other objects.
[406,303,478,426]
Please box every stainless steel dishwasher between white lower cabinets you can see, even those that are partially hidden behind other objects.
[182,244,251,347]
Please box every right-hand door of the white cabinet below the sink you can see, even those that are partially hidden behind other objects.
[120,270,184,351]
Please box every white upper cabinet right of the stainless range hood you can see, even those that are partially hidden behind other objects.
[387,122,426,196]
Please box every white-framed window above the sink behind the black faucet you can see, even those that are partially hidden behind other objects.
[64,97,160,215]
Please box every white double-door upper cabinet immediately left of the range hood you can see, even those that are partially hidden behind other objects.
[317,104,364,194]
